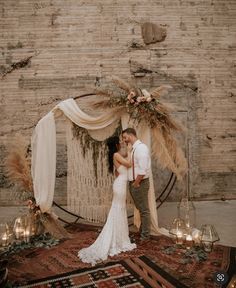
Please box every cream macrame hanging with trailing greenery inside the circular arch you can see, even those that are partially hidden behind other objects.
[66,121,132,223]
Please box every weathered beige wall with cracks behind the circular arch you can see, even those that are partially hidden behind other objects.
[0,0,236,205]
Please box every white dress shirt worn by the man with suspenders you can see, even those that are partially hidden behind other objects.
[128,140,151,181]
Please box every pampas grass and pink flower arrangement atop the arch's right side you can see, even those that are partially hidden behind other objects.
[94,77,187,179]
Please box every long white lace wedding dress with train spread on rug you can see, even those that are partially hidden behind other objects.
[78,165,136,265]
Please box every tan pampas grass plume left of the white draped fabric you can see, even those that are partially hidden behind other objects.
[5,137,33,192]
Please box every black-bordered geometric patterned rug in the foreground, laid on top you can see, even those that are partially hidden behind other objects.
[16,256,187,288]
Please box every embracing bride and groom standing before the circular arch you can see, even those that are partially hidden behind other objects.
[78,128,151,265]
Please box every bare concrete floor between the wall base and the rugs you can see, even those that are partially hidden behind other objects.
[0,200,236,247]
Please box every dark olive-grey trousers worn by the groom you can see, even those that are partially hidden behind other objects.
[129,178,150,239]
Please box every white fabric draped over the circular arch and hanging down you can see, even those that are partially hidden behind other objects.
[31,99,166,234]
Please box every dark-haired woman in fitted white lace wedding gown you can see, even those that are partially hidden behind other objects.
[78,136,136,265]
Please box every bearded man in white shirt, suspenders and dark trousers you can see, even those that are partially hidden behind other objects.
[122,128,151,240]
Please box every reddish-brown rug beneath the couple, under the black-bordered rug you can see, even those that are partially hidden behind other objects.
[4,225,235,288]
